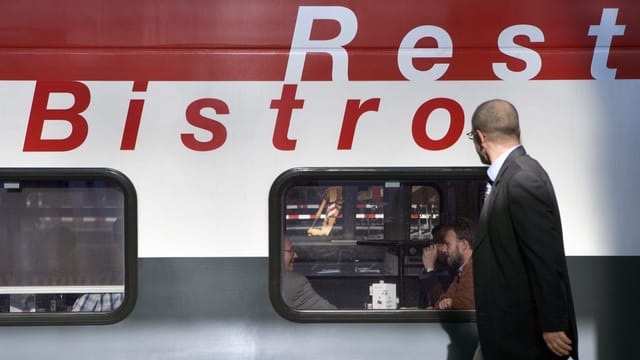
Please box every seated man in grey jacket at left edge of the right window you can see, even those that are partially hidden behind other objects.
[282,237,336,310]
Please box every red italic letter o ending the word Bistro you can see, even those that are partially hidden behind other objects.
[411,98,464,151]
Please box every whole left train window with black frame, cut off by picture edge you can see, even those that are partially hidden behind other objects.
[0,169,137,325]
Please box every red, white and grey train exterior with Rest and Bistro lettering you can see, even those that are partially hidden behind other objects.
[0,0,640,359]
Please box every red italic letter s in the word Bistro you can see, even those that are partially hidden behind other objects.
[180,99,229,151]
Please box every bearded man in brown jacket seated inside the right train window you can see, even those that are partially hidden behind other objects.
[435,218,475,310]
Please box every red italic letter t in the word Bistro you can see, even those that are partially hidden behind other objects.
[270,85,304,150]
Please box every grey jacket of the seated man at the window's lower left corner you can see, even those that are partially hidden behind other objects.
[282,271,336,310]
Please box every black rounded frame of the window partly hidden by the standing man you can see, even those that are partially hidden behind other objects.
[269,167,486,323]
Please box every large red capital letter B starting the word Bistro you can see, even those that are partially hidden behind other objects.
[22,81,91,151]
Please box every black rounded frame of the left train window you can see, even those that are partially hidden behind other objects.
[0,168,138,326]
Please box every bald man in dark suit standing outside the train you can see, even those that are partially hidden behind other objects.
[468,100,578,360]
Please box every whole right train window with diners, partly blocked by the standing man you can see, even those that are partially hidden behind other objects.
[269,167,486,322]
